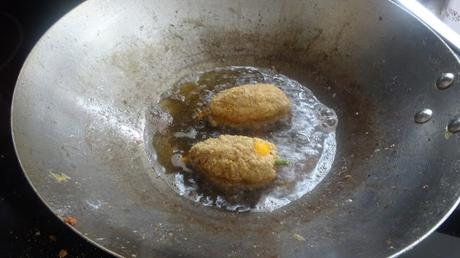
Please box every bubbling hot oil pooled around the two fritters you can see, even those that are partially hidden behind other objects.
[146,67,337,211]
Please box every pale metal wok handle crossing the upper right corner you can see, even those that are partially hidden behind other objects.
[390,0,460,56]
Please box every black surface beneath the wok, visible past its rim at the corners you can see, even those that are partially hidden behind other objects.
[0,0,460,258]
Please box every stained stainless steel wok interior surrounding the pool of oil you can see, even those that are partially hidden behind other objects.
[12,0,460,257]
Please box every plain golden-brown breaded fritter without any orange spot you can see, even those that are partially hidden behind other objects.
[208,83,290,128]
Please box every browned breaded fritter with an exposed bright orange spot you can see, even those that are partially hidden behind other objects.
[188,135,277,188]
